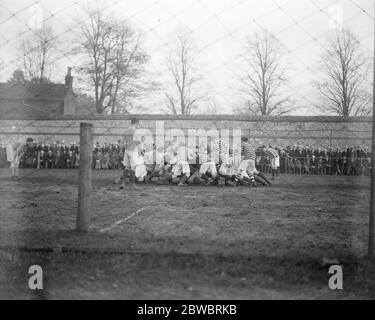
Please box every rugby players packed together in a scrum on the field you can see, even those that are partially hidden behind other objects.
[115,136,280,189]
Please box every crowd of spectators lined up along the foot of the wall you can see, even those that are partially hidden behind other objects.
[0,141,371,175]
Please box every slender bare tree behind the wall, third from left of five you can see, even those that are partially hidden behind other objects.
[164,29,206,114]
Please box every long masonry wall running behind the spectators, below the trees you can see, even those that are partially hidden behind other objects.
[0,115,372,147]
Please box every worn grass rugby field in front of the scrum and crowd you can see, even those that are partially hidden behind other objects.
[0,170,375,299]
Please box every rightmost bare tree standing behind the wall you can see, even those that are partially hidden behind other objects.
[314,29,372,117]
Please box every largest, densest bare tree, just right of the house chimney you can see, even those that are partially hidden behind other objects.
[80,10,148,114]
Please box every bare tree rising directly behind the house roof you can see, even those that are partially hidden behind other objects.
[20,25,59,82]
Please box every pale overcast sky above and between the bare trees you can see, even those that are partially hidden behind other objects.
[0,0,374,115]
